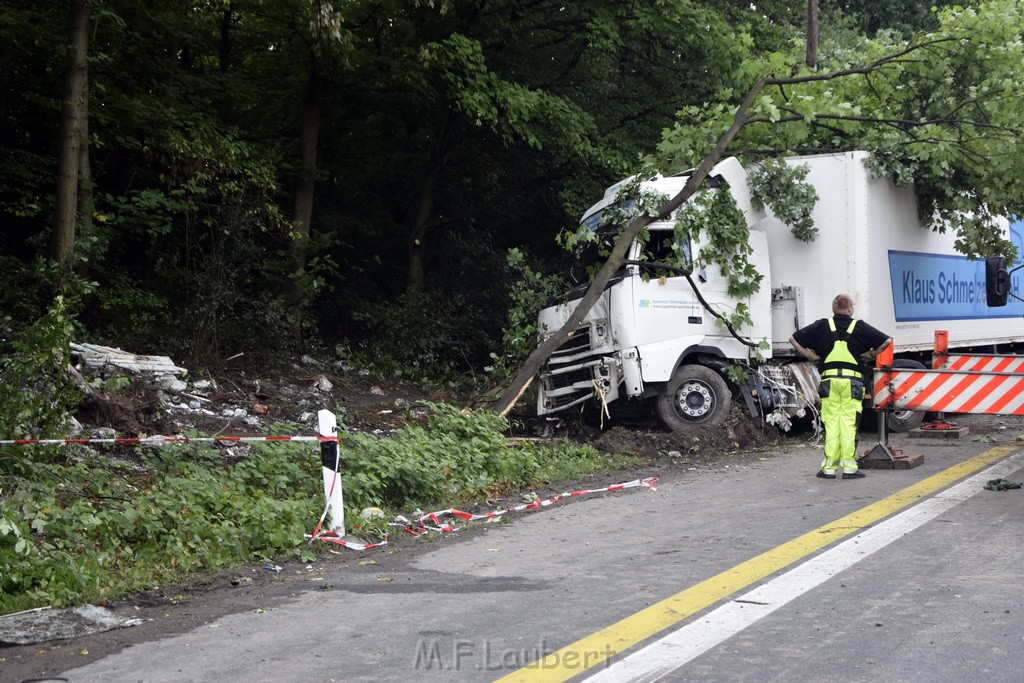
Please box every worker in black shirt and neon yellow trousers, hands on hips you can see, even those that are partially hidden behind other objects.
[790,294,893,479]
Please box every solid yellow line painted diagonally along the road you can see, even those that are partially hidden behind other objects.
[498,444,1020,683]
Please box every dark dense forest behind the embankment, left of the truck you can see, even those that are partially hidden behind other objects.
[0,0,941,395]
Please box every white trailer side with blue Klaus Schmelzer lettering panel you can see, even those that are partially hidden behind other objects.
[752,152,1024,355]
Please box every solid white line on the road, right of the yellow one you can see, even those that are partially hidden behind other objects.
[586,453,1024,683]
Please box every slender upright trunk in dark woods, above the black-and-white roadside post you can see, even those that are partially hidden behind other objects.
[284,62,321,322]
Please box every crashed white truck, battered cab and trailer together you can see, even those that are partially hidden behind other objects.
[537,152,1024,431]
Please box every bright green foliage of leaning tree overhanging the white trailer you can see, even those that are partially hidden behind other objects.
[658,0,1024,264]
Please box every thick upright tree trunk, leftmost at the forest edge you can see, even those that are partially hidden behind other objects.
[50,0,90,266]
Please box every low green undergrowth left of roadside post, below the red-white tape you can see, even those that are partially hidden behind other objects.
[0,443,323,612]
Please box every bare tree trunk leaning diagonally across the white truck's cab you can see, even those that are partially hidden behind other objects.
[492,79,767,415]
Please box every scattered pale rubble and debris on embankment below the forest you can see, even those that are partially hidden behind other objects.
[72,344,444,440]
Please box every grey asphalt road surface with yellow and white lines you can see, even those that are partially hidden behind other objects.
[62,418,1024,683]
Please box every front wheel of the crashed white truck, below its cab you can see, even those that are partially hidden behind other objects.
[657,366,732,431]
